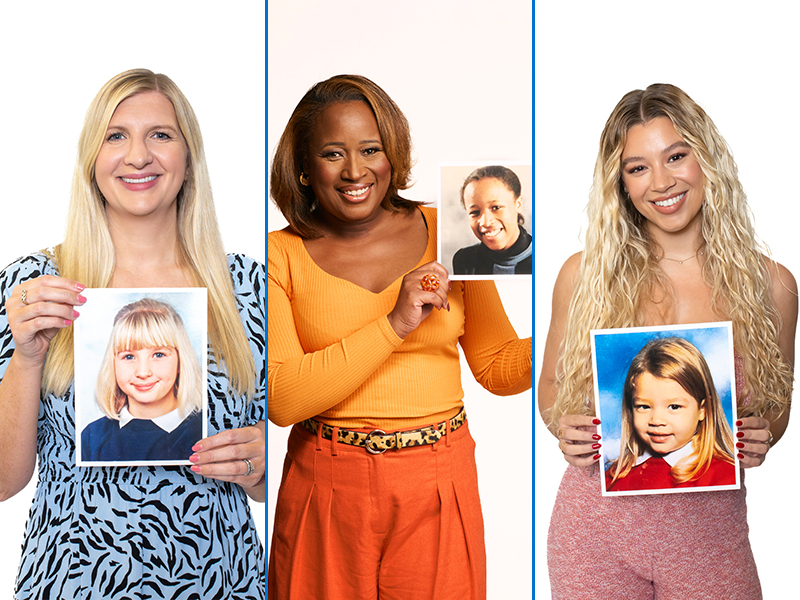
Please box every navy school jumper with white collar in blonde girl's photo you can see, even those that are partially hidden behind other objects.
[81,406,203,461]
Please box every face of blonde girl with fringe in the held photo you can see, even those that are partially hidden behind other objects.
[114,348,180,419]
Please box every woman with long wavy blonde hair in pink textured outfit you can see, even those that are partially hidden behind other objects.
[538,84,797,600]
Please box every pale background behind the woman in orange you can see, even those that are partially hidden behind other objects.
[267,0,534,599]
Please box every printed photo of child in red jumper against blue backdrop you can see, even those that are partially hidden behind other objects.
[591,322,739,496]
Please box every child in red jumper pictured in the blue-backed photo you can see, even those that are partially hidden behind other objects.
[606,337,736,491]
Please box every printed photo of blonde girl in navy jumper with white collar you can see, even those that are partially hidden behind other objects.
[75,288,208,466]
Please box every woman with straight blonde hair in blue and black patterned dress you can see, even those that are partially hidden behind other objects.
[0,69,265,600]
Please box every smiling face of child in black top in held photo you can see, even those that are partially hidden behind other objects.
[464,177,522,250]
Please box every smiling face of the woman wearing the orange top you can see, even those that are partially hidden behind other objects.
[306,102,392,223]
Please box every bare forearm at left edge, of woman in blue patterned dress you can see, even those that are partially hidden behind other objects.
[0,356,42,500]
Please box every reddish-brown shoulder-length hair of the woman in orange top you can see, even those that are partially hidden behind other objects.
[269,75,419,239]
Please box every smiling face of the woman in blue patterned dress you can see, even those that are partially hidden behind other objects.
[95,92,189,224]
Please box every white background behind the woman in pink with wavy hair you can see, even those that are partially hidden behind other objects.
[535,1,800,600]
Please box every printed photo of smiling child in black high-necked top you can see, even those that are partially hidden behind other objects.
[438,162,533,279]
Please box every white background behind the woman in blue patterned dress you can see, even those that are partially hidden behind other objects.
[0,0,265,598]
